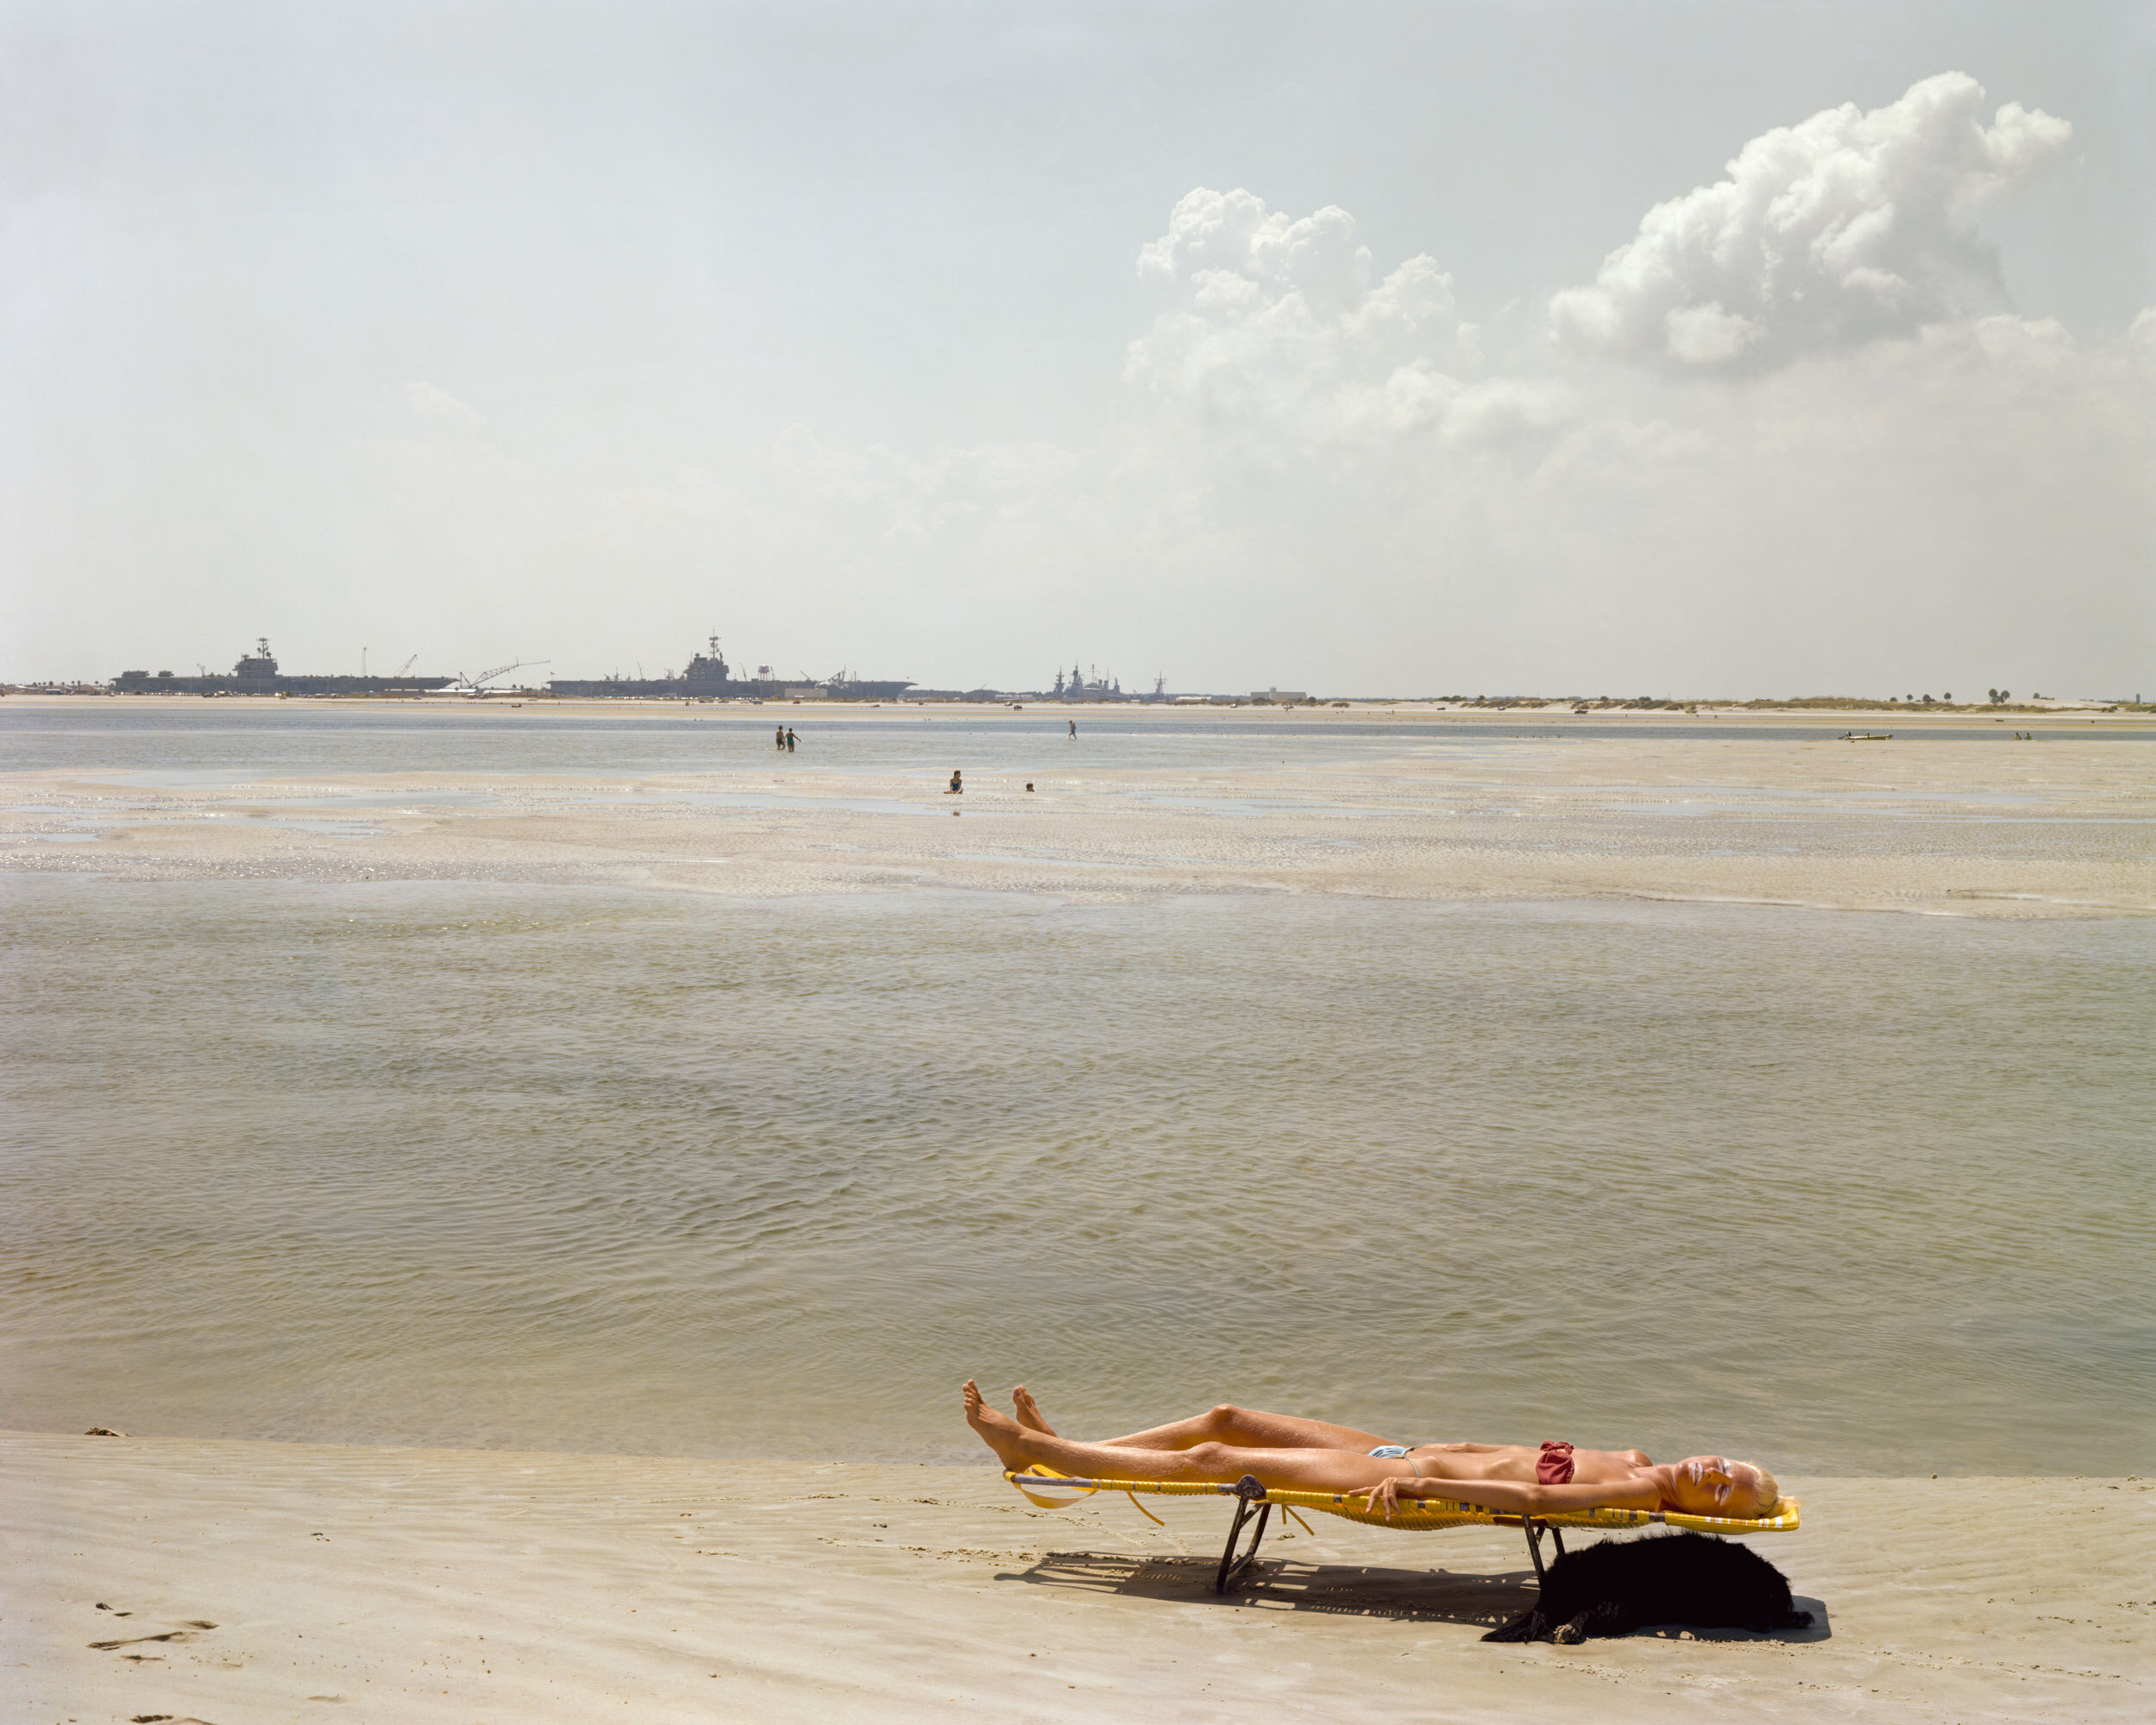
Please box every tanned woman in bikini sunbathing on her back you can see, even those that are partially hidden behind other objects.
[966,1378,1781,1520]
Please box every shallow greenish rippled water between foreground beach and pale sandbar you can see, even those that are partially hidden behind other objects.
[0,875,2156,1475]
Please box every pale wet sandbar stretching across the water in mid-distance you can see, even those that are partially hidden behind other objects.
[0,708,2156,916]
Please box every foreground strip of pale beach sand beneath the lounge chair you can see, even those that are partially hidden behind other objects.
[0,1436,2156,1725]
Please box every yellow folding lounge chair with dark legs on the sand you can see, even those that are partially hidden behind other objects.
[1003,1466,1805,1594]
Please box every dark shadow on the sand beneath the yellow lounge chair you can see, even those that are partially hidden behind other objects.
[996,1551,1537,1630]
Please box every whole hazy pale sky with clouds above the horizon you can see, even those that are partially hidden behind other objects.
[0,0,2156,699]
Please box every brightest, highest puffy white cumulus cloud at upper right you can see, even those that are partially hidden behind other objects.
[1550,71,2074,371]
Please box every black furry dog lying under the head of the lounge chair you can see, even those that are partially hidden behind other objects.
[1483,1533,1811,1643]
